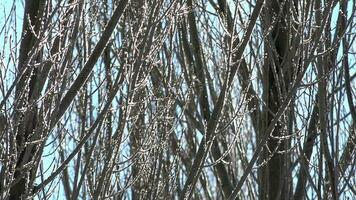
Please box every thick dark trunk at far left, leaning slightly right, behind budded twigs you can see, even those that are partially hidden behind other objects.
[10,0,44,199]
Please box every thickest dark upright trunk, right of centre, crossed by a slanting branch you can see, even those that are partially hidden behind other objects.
[259,0,290,200]
